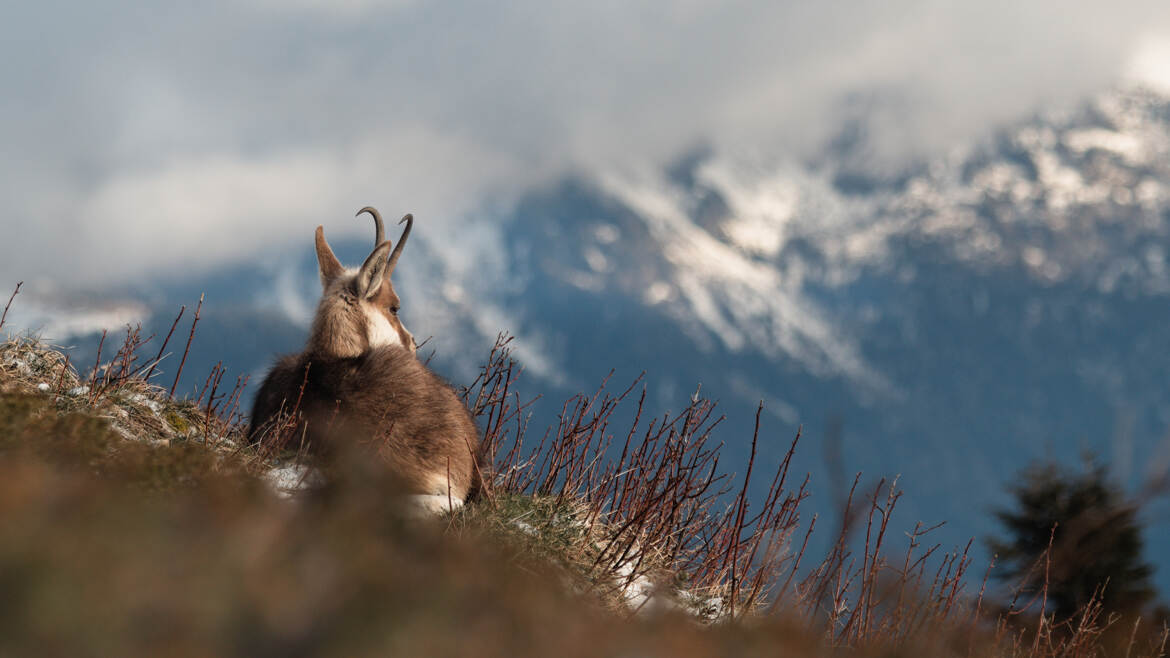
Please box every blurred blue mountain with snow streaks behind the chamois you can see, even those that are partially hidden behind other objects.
[16,83,1170,592]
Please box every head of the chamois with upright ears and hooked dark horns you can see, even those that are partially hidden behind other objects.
[308,206,415,357]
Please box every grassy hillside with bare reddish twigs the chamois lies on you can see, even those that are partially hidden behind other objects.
[0,320,1166,656]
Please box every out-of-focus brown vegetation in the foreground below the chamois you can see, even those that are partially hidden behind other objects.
[0,381,814,656]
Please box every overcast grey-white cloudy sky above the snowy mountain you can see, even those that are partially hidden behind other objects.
[0,0,1170,287]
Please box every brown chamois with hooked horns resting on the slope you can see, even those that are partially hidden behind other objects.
[248,206,480,512]
